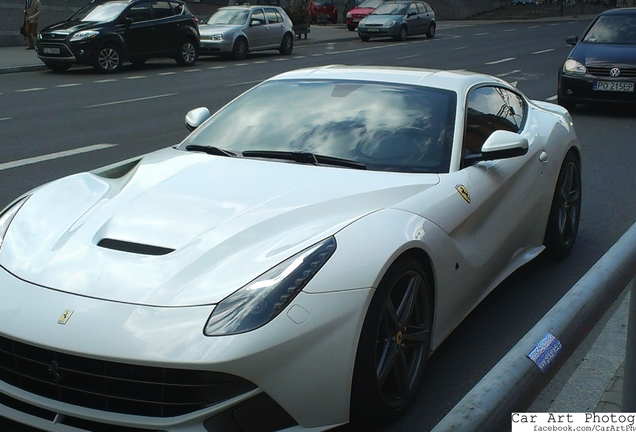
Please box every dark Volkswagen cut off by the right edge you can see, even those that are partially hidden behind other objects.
[558,8,636,110]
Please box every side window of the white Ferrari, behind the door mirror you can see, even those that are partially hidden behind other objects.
[464,87,526,156]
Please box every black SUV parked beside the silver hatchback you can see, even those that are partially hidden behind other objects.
[37,0,199,72]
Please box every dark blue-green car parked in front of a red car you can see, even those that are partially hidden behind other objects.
[358,1,436,42]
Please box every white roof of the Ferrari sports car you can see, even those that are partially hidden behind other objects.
[270,65,511,94]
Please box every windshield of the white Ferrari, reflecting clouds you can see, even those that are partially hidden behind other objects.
[179,80,456,173]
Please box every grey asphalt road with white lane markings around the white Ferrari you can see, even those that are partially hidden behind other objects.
[0,18,636,432]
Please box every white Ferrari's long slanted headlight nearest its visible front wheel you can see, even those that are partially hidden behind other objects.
[203,237,336,336]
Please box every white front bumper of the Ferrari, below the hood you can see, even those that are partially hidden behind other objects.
[0,267,372,432]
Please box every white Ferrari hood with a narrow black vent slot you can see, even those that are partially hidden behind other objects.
[0,149,439,306]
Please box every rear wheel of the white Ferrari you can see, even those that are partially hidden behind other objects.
[543,152,581,260]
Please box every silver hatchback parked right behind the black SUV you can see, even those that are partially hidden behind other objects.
[199,6,294,60]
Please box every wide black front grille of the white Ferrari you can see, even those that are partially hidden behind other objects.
[0,336,256,417]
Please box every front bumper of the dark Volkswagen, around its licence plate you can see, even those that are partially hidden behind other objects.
[558,72,636,103]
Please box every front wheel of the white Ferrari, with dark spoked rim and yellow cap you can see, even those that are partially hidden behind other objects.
[351,257,432,423]
